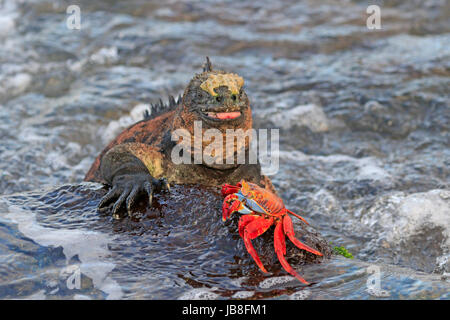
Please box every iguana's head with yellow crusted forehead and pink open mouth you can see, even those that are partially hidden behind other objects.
[174,58,252,169]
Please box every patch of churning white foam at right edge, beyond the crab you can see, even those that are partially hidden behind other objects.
[361,189,450,273]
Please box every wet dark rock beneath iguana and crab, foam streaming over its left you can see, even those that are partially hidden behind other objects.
[0,183,331,299]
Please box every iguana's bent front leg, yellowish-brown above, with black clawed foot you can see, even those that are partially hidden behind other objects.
[98,143,170,217]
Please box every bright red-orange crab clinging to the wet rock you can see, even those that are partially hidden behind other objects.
[222,180,322,284]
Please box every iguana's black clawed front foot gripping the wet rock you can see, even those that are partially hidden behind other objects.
[98,173,170,219]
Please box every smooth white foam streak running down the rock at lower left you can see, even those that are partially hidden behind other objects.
[5,205,123,299]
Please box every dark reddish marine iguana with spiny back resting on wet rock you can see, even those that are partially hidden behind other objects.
[84,57,275,216]
